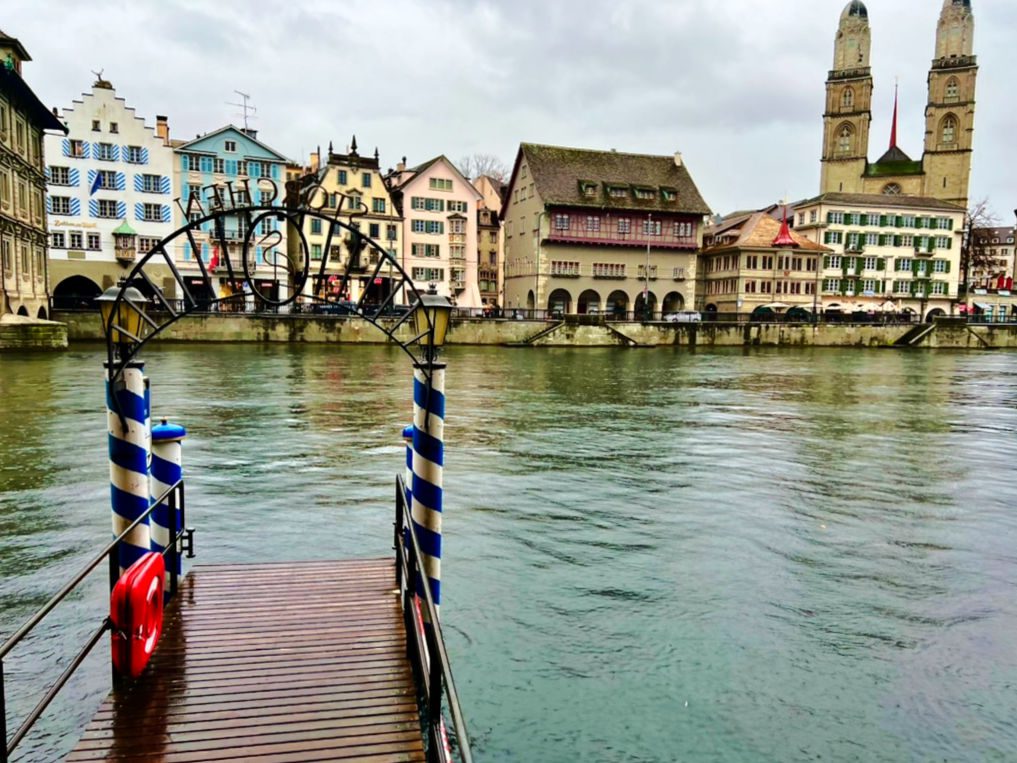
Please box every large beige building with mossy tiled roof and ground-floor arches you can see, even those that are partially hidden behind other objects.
[501,143,710,318]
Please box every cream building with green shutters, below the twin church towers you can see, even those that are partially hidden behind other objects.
[795,193,965,319]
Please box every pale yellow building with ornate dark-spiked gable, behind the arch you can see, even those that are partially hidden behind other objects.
[288,136,400,304]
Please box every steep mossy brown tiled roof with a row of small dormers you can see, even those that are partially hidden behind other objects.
[513,143,710,215]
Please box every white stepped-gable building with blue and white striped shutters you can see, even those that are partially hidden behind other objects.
[46,78,178,308]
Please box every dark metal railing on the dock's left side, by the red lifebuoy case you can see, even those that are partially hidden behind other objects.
[0,479,194,763]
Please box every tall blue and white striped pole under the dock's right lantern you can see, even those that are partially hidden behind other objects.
[411,363,445,606]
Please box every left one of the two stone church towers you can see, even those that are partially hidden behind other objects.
[820,0,873,193]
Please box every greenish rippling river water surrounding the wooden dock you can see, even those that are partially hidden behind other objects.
[0,345,1017,761]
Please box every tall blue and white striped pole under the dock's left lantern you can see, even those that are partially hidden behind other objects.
[106,361,152,575]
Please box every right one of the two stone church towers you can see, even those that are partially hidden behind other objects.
[923,0,978,209]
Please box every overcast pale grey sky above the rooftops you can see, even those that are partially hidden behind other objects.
[7,0,1017,223]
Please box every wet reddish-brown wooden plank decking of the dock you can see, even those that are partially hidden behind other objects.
[67,560,424,763]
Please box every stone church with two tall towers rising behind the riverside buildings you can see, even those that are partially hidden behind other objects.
[820,0,978,209]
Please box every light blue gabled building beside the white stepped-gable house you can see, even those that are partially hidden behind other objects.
[174,125,290,309]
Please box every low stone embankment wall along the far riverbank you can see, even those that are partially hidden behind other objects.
[54,312,1017,350]
